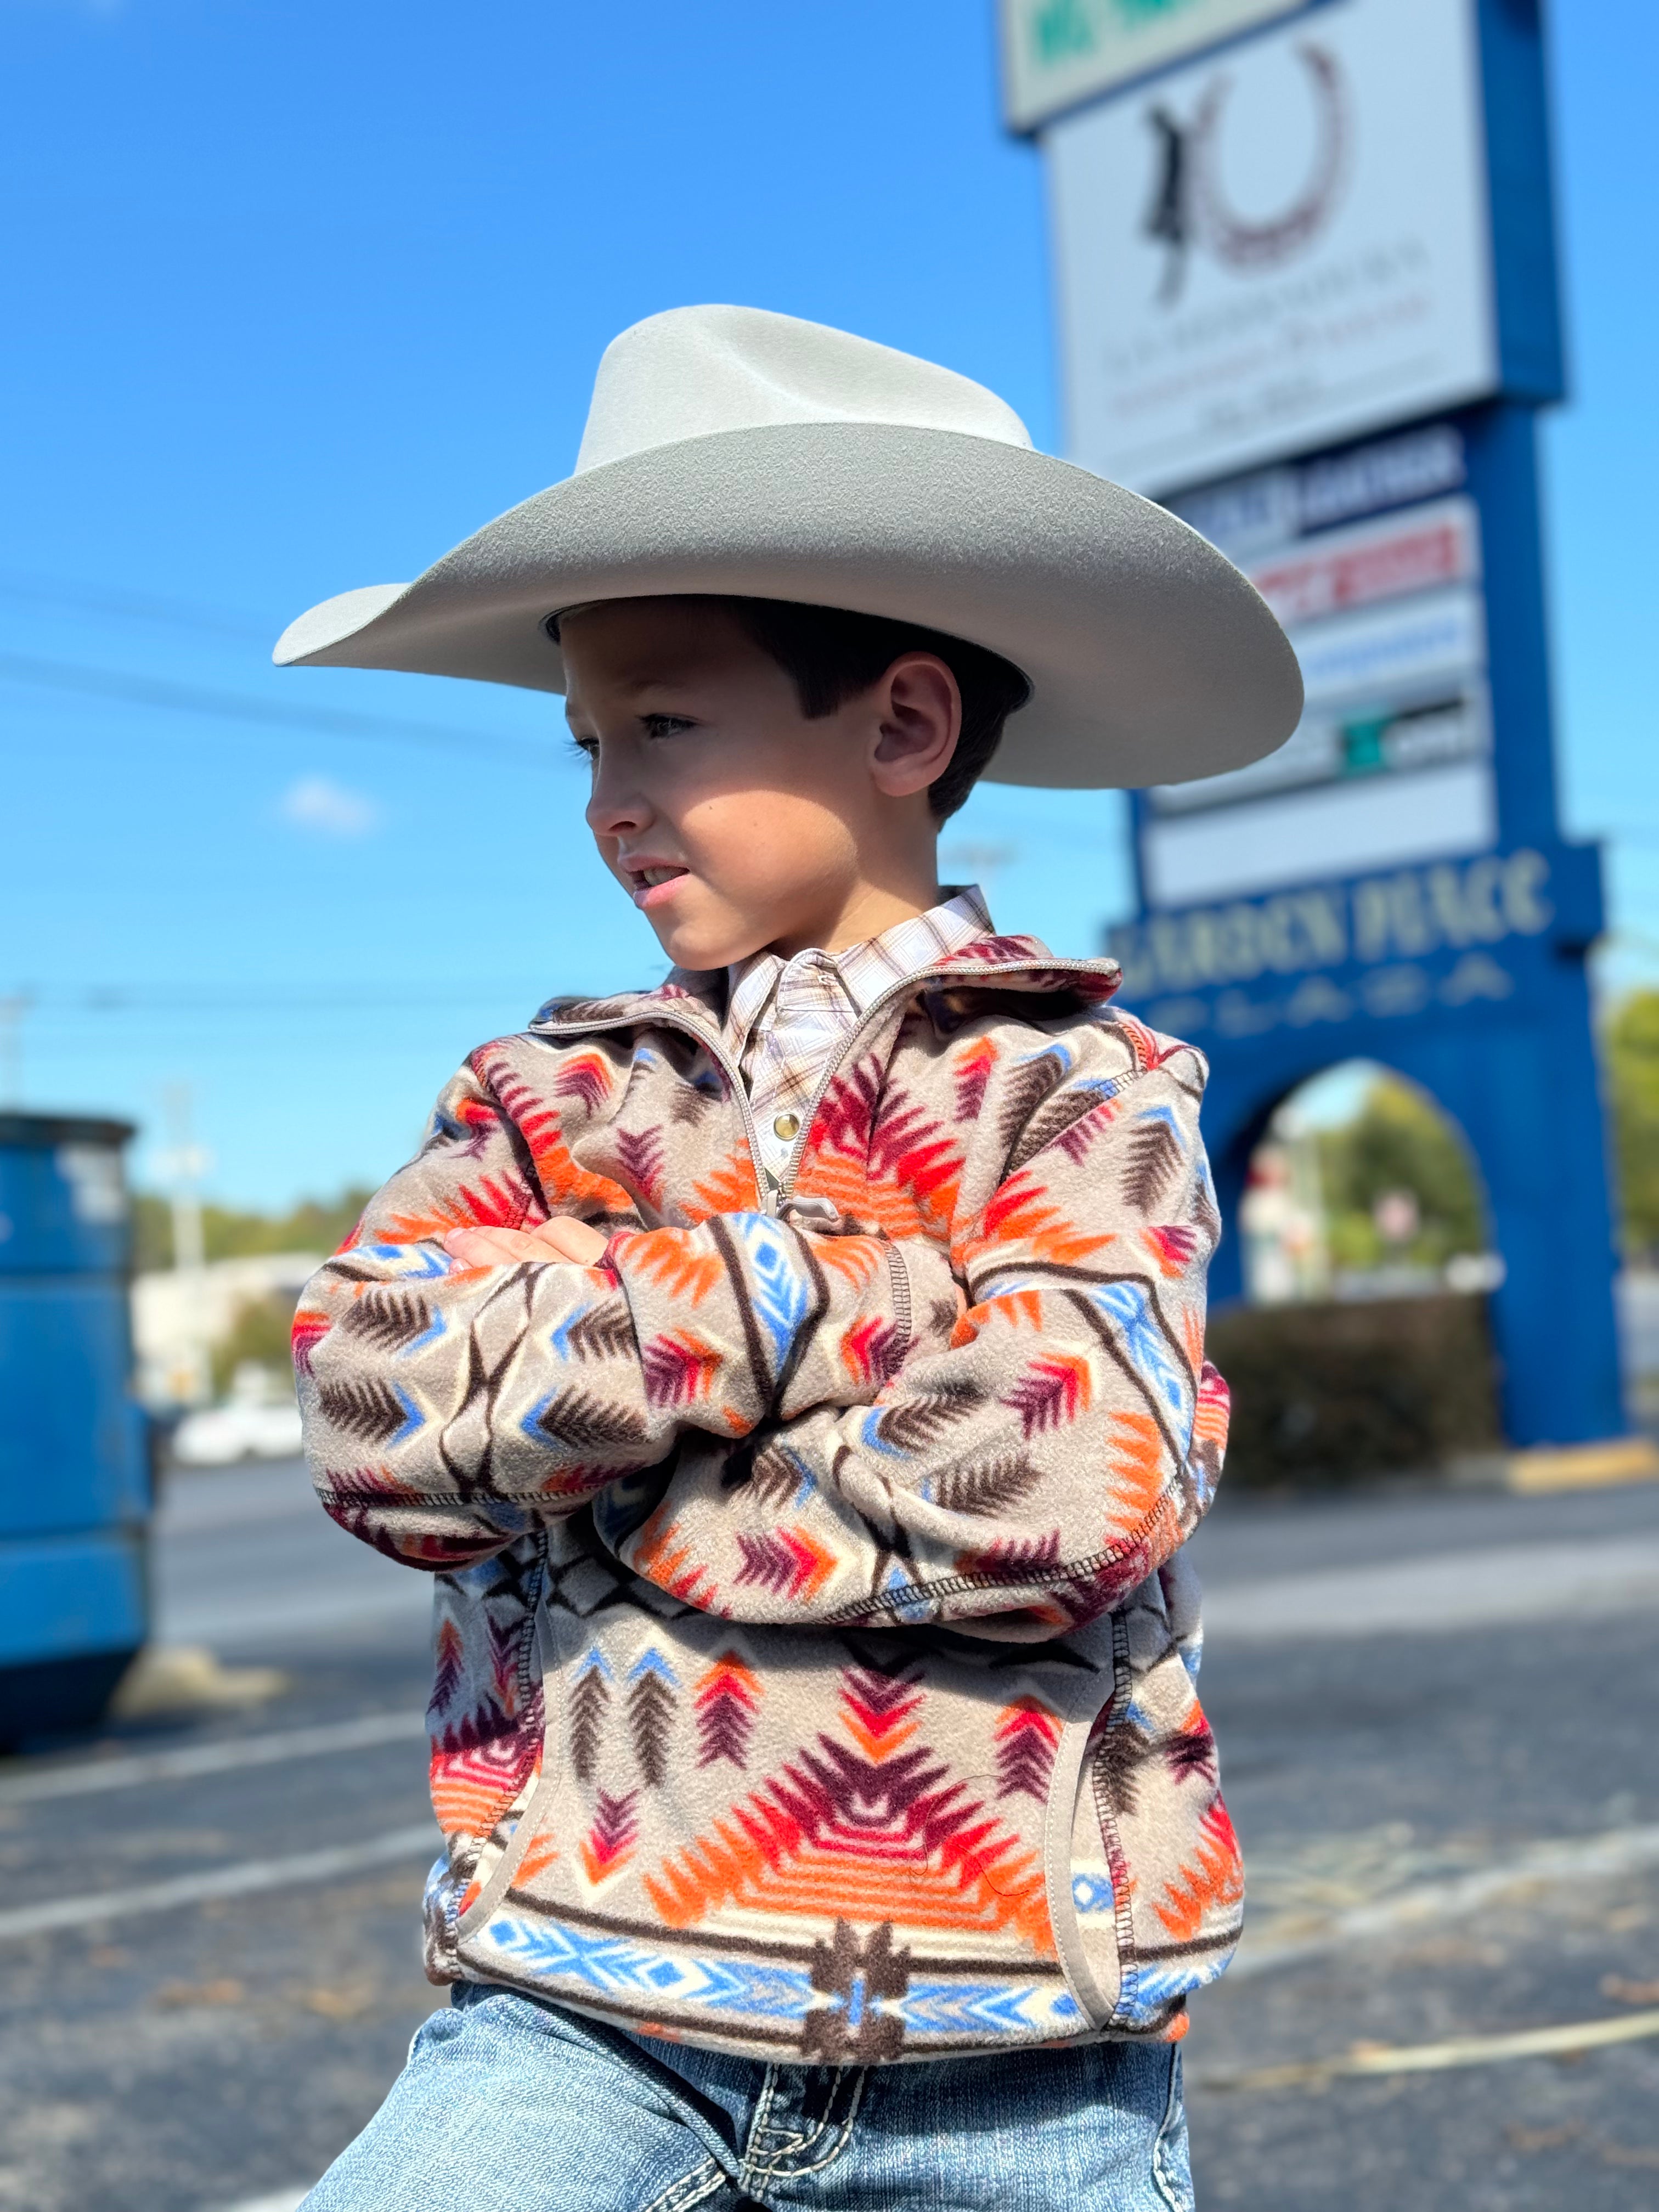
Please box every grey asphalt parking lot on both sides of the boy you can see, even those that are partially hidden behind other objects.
[0,1466,1659,2212]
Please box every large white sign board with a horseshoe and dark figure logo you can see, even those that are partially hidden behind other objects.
[1044,0,1500,495]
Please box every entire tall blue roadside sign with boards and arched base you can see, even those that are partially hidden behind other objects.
[1005,0,1623,1444]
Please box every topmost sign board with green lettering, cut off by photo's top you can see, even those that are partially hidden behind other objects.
[1002,0,1314,131]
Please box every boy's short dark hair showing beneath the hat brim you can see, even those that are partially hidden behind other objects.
[714,597,1031,821]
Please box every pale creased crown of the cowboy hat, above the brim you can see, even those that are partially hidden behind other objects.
[575,307,1031,476]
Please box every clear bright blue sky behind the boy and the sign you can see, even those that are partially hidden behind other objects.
[0,0,1659,1203]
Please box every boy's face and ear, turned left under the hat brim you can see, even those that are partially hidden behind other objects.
[560,600,960,969]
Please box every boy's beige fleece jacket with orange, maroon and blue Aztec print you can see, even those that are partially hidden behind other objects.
[296,938,1243,2064]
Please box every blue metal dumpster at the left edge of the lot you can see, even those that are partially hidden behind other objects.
[0,1113,150,1745]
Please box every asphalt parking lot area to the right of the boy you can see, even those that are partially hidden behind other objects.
[1186,1487,1659,2212]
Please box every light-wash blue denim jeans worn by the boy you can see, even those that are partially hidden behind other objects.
[301,1984,1192,2212]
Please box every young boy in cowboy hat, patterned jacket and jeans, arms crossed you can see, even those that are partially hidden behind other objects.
[276,307,1301,2212]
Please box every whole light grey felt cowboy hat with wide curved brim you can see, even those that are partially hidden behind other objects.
[274,307,1303,787]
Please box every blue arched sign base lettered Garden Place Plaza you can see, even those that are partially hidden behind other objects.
[1113,809,1621,1444]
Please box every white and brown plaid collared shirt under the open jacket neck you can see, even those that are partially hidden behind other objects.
[725,883,991,1190]
